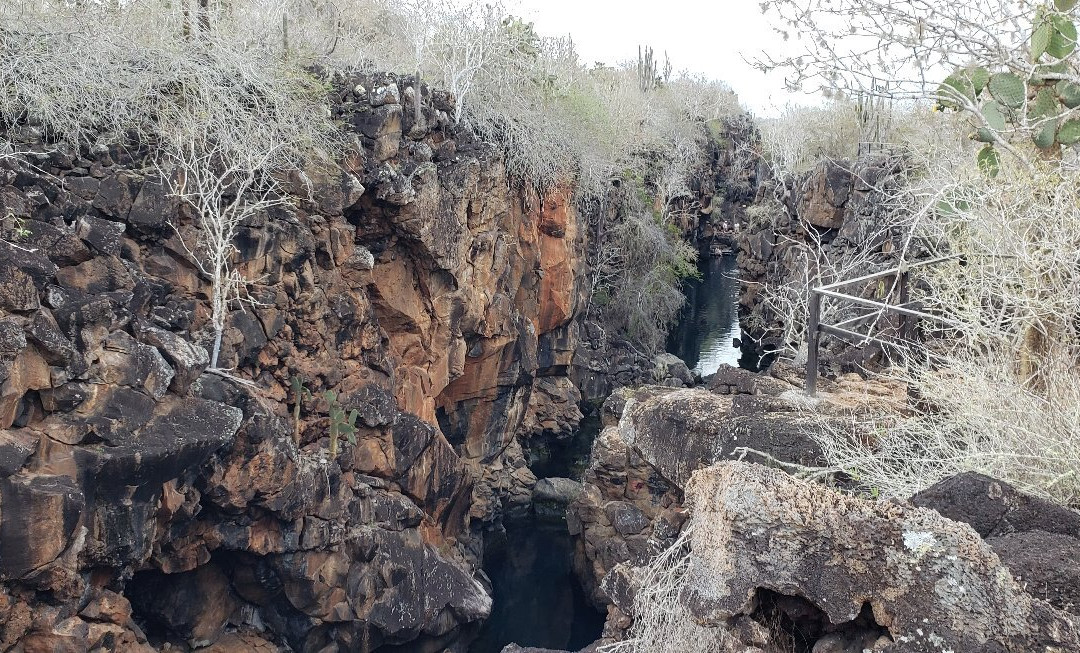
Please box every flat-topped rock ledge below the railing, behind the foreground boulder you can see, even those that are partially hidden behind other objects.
[568,363,904,606]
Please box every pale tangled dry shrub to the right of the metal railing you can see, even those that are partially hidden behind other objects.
[807,132,1080,504]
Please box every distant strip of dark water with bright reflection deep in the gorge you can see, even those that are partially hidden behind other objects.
[667,255,742,377]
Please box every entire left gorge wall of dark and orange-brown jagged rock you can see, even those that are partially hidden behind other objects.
[0,76,600,652]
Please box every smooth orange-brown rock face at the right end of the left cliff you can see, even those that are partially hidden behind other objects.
[356,165,584,458]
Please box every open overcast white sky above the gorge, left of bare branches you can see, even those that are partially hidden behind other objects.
[511,0,816,112]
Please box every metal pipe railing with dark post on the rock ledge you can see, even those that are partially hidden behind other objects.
[806,254,961,397]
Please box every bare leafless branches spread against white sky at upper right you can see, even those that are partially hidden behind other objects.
[756,0,1032,98]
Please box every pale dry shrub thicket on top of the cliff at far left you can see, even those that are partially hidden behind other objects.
[0,0,330,158]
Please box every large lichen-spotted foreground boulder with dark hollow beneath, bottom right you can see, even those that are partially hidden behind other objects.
[683,462,1080,653]
